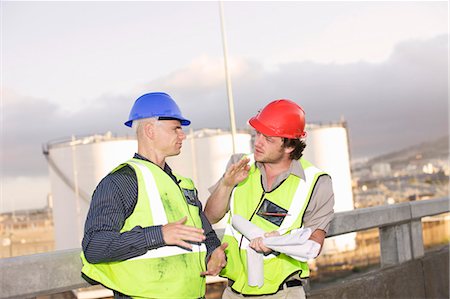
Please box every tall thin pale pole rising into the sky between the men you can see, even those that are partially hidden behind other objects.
[219,1,236,154]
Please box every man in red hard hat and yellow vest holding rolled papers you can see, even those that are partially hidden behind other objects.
[205,99,334,299]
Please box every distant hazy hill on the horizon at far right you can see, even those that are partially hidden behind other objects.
[365,135,449,166]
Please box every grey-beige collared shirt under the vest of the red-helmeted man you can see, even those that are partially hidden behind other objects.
[209,154,334,232]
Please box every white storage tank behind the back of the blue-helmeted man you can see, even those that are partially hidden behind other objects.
[44,133,137,250]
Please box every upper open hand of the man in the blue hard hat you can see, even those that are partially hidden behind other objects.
[162,216,206,249]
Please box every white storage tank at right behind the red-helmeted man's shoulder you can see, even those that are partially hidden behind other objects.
[303,122,356,253]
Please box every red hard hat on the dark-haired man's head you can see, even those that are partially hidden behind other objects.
[248,99,306,139]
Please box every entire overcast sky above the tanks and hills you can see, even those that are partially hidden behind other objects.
[0,1,449,212]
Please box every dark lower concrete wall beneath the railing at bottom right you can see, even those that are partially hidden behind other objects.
[308,246,449,299]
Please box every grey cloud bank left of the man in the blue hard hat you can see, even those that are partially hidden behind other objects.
[1,95,130,176]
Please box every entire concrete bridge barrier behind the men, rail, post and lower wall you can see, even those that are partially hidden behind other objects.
[0,198,449,299]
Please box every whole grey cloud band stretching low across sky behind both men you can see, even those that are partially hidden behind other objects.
[1,35,449,176]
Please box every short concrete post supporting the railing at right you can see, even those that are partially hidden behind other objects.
[379,223,412,267]
